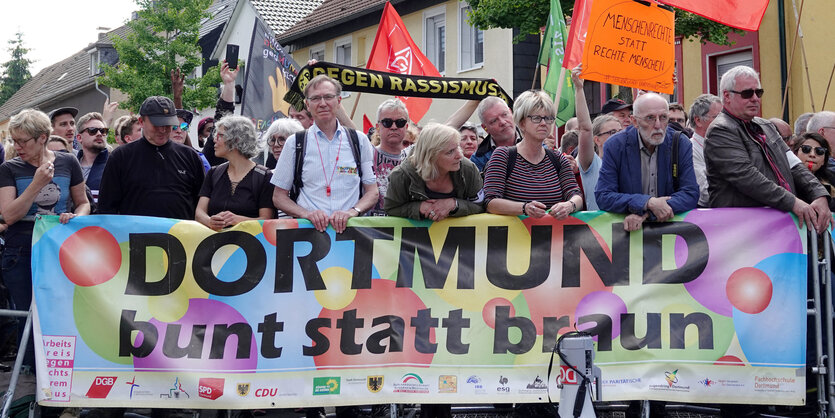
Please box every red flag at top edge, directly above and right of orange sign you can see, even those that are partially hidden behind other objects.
[659,0,768,31]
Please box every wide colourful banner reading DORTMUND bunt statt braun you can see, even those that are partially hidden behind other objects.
[32,209,806,409]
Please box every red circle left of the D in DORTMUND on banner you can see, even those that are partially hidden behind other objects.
[58,226,122,286]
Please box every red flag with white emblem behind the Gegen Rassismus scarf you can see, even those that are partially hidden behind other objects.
[366,2,441,123]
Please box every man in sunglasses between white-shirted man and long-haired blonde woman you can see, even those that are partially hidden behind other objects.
[370,99,409,216]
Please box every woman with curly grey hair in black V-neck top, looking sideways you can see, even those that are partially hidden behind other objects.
[194,116,275,231]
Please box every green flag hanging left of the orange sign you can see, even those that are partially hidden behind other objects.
[537,0,574,126]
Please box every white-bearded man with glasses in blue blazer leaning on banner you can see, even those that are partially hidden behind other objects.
[595,93,699,231]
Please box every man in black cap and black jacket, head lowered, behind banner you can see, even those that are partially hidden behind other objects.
[99,96,203,219]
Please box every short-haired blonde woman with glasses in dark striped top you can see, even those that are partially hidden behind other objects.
[484,90,583,219]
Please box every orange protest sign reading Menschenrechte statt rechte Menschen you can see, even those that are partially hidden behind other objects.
[580,0,675,94]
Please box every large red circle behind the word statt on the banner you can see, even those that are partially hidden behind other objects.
[308,279,438,367]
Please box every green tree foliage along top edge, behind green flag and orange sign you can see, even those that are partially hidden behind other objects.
[469,0,743,45]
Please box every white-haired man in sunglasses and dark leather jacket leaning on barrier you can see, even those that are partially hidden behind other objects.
[705,66,832,232]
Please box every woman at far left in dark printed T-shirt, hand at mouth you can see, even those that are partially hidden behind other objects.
[0,109,90,367]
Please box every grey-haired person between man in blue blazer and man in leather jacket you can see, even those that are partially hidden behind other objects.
[690,94,722,208]
